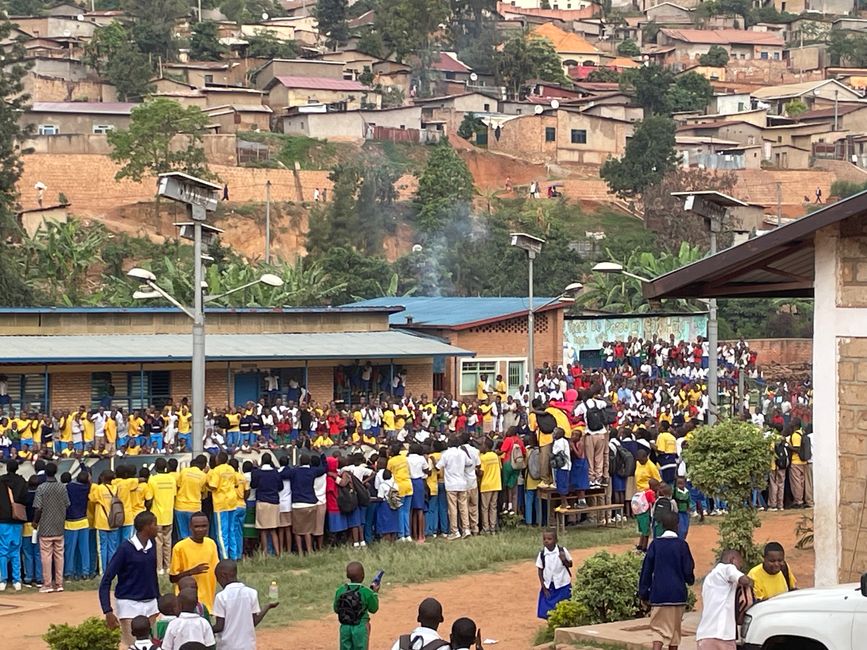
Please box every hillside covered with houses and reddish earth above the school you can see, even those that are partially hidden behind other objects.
[0,0,867,268]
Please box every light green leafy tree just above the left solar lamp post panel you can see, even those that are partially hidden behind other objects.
[108,97,210,182]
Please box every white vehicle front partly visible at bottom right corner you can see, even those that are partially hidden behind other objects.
[741,574,867,650]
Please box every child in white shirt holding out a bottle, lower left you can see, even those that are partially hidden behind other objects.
[211,560,277,650]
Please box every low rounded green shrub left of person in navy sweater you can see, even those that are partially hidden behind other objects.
[572,551,641,624]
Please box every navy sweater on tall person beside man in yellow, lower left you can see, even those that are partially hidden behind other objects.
[99,540,160,614]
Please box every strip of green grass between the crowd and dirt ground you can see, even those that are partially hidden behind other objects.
[65,527,634,627]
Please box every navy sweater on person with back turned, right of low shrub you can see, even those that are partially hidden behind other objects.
[638,537,695,606]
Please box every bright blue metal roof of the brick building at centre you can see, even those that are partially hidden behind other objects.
[345,296,557,328]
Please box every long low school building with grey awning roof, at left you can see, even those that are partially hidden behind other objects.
[0,307,473,411]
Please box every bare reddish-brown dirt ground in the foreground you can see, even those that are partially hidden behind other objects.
[0,512,814,650]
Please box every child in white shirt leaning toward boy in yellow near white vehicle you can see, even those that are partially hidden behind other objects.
[695,550,753,650]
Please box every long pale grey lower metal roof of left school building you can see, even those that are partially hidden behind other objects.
[0,330,474,363]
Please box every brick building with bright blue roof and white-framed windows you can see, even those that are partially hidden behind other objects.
[348,296,571,397]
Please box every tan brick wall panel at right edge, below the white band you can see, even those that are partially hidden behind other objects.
[837,338,867,582]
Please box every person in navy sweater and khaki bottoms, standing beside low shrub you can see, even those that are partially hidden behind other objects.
[638,511,695,650]
